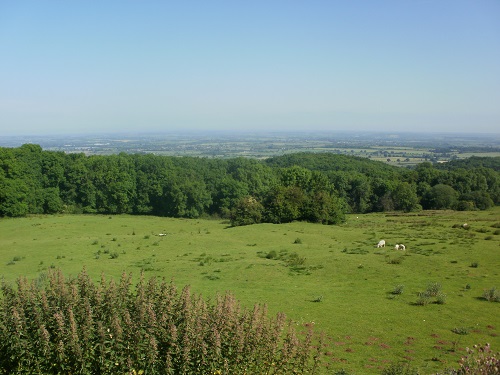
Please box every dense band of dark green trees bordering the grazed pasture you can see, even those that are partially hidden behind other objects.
[0,144,500,225]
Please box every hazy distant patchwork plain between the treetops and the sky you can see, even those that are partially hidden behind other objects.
[0,132,500,167]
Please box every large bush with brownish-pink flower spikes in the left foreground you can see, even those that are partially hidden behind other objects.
[0,270,321,374]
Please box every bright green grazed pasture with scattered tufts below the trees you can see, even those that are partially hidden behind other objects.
[0,207,500,374]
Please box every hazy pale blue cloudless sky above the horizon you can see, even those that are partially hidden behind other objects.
[0,0,500,135]
